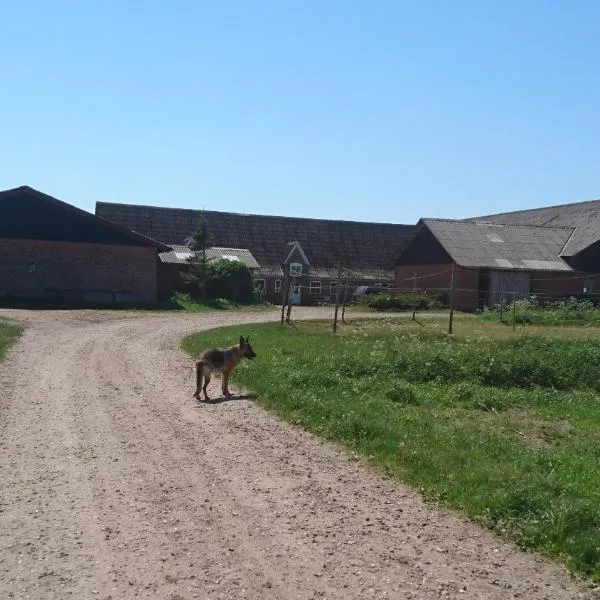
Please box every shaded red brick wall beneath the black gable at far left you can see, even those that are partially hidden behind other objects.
[0,239,158,302]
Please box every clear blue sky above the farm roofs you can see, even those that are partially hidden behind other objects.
[0,0,600,223]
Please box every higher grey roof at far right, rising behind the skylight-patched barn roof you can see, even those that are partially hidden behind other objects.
[467,200,600,256]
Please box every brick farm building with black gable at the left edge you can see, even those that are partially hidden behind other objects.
[0,186,169,303]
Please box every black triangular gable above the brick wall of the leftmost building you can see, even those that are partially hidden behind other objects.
[0,185,168,247]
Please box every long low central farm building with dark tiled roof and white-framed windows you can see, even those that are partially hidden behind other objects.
[96,202,414,304]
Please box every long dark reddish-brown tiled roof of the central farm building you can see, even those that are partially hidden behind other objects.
[96,202,415,271]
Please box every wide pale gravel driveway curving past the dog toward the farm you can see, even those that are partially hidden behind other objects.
[0,309,592,600]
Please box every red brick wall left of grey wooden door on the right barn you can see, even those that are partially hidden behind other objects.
[395,264,479,311]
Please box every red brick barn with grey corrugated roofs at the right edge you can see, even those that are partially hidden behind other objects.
[395,201,600,311]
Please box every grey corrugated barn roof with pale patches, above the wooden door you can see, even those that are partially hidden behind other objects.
[421,219,573,271]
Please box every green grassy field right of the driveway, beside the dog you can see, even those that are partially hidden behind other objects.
[182,317,600,581]
